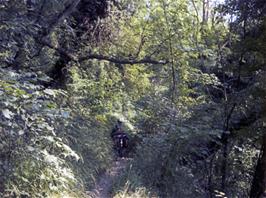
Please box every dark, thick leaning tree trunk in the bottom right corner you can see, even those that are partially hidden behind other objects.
[250,131,266,198]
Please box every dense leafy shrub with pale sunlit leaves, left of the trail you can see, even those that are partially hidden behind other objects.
[0,69,111,197]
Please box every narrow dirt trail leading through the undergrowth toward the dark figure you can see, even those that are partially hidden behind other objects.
[87,158,130,198]
